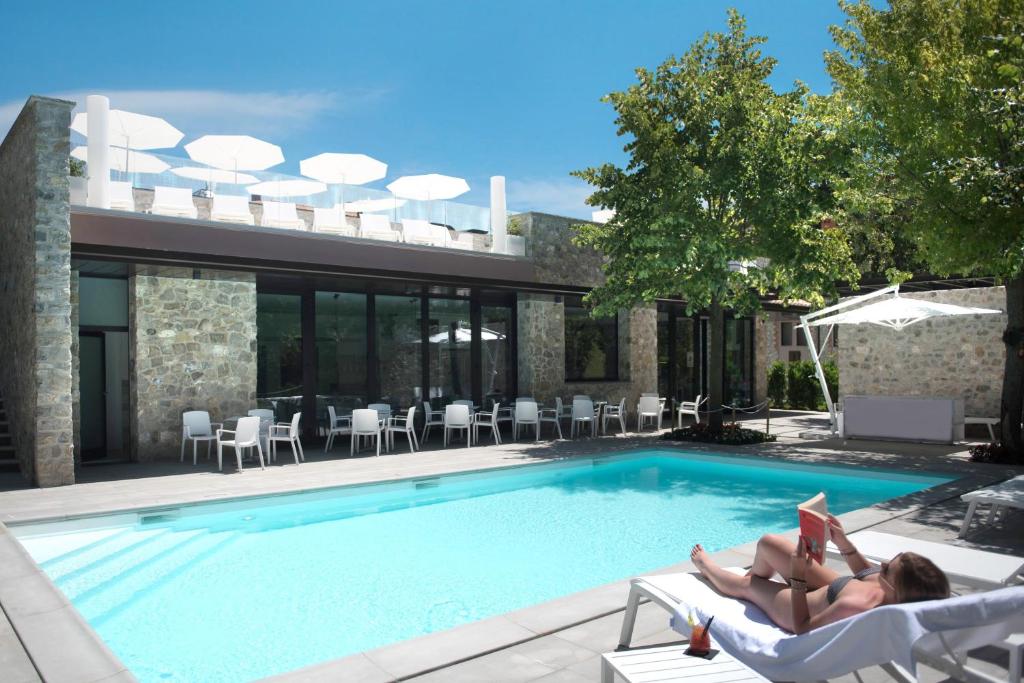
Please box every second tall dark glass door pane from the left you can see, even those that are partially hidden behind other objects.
[315,292,368,424]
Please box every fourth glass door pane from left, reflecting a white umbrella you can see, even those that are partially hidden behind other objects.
[427,299,473,408]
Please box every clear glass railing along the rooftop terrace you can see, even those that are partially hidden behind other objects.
[72,151,521,255]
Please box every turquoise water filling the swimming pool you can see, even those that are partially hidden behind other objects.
[15,451,948,682]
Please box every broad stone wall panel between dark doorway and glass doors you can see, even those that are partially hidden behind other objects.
[128,267,256,461]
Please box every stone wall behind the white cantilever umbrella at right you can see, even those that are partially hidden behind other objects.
[839,287,1007,417]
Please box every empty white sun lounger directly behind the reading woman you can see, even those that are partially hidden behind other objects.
[827,529,1024,589]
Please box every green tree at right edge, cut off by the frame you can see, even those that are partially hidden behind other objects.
[826,0,1024,453]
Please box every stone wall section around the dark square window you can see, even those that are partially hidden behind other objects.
[517,294,657,421]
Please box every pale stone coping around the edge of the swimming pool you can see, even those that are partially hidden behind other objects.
[0,442,997,683]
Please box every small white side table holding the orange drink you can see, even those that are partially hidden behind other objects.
[601,645,769,683]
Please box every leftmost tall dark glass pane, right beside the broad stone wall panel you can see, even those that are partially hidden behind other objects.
[256,293,302,422]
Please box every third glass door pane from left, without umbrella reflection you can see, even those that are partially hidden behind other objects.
[374,295,423,411]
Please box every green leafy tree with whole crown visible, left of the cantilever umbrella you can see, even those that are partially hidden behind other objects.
[574,10,858,429]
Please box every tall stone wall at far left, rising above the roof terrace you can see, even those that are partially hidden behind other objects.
[0,97,75,486]
